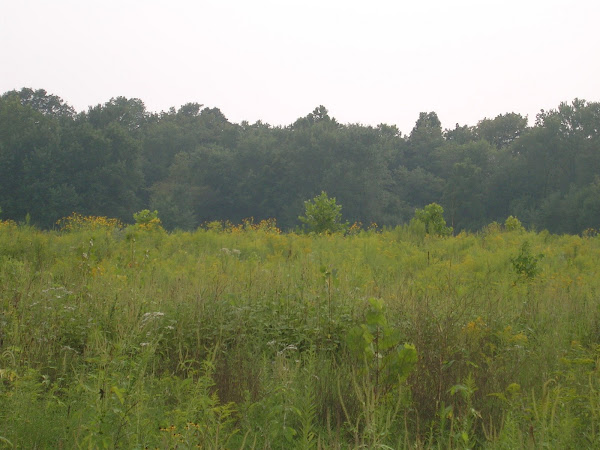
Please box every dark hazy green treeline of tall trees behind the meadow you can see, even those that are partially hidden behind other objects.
[0,88,600,233]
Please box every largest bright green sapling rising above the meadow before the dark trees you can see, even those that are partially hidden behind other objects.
[298,191,347,233]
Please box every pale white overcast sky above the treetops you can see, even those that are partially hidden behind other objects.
[0,0,600,134]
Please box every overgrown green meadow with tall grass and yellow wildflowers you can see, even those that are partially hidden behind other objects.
[0,216,600,449]
